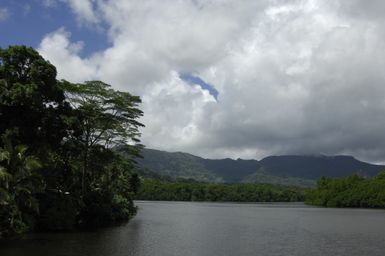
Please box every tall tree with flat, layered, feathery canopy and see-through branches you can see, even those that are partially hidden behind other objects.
[61,81,143,194]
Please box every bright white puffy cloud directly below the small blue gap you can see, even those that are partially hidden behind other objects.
[141,71,215,153]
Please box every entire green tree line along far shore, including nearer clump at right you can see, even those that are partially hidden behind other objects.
[135,171,385,208]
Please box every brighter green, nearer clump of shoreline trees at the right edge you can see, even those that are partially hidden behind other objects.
[306,172,385,208]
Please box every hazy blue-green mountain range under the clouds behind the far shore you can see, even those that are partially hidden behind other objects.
[137,149,385,186]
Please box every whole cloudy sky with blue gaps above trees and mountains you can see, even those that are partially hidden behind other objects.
[0,0,385,163]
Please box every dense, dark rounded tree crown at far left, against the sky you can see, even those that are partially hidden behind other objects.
[0,46,68,153]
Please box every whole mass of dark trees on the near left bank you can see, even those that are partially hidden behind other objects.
[0,46,142,236]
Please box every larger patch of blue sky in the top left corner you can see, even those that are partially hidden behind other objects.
[0,0,110,57]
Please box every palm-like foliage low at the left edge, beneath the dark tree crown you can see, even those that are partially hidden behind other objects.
[0,133,43,235]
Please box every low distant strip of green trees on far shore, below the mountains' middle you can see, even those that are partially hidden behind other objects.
[136,179,307,202]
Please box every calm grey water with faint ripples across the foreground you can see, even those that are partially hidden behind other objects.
[0,202,385,256]
